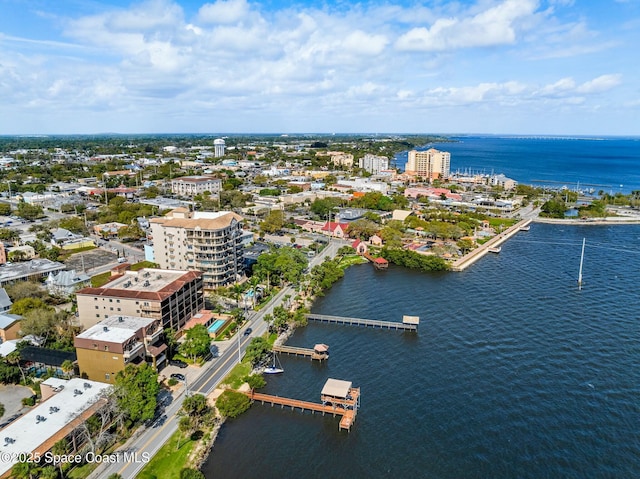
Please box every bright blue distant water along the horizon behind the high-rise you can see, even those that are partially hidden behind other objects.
[396,136,640,194]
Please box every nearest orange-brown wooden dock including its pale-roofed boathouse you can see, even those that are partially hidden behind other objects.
[244,379,360,431]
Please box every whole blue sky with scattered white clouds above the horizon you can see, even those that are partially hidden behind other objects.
[0,0,640,135]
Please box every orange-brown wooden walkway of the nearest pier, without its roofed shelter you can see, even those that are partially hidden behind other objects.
[243,388,360,431]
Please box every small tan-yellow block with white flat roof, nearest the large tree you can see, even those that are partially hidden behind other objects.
[73,315,167,384]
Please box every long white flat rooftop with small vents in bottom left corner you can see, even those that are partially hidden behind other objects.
[0,378,111,476]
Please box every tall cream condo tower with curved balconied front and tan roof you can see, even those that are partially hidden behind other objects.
[150,208,243,289]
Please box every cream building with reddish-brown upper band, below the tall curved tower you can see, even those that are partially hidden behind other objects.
[76,268,204,331]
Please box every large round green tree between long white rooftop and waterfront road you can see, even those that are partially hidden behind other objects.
[114,363,160,424]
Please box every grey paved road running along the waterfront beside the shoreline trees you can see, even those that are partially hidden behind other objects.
[90,240,349,479]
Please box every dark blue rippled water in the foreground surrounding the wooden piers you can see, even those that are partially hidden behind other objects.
[204,224,640,479]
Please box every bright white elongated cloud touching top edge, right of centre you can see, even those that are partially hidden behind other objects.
[396,0,538,51]
